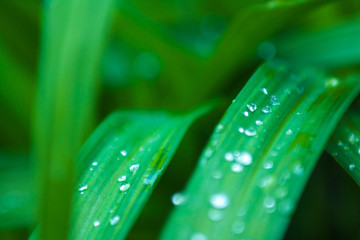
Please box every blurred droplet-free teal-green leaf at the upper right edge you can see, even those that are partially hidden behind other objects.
[274,19,360,68]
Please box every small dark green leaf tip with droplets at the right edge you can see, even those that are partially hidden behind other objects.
[326,101,360,185]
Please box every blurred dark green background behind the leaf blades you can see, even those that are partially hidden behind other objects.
[0,0,360,240]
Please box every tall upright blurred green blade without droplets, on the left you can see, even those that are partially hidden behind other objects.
[34,0,114,240]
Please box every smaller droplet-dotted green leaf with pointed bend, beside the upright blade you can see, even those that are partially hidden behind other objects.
[71,106,209,239]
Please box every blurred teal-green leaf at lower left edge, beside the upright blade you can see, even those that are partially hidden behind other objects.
[0,152,36,230]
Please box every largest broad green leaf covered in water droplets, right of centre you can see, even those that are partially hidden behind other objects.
[162,62,360,239]
